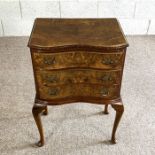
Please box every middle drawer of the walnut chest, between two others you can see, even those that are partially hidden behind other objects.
[36,69,121,86]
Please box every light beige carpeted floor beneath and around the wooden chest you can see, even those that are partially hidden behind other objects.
[0,36,155,155]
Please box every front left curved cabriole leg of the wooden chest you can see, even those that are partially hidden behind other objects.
[32,104,45,147]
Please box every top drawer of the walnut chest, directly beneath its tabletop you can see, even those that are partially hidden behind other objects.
[32,51,124,70]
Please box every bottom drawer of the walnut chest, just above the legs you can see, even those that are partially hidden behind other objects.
[39,84,119,100]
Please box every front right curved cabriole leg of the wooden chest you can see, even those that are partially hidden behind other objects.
[111,101,124,144]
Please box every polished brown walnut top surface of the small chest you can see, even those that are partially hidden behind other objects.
[28,18,128,49]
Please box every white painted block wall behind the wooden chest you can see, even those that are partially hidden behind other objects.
[0,0,155,36]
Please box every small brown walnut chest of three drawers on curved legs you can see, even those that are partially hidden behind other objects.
[28,18,128,146]
